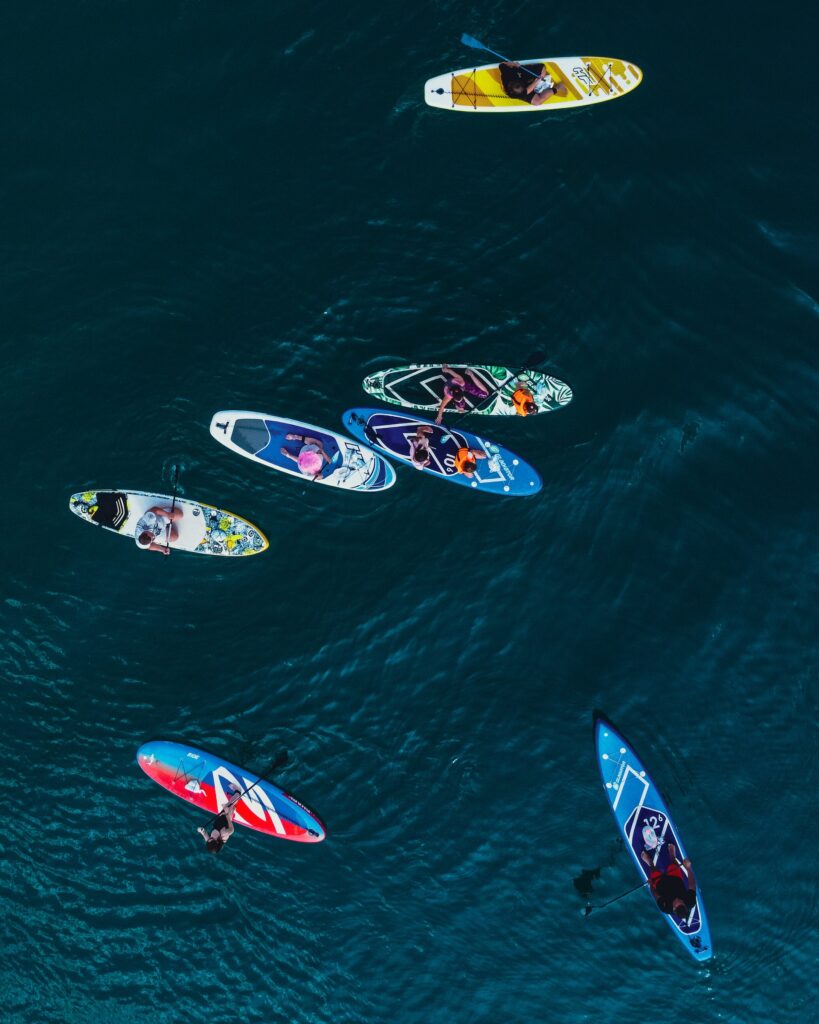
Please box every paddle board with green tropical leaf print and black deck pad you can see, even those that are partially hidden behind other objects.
[362,362,572,416]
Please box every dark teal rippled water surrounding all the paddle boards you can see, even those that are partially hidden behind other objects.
[0,0,819,1024]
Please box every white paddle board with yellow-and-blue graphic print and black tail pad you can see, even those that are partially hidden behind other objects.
[69,490,268,557]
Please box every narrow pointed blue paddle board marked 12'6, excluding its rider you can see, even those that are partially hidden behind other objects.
[594,712,714,963]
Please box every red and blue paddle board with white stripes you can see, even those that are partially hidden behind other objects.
[136,739,326,843]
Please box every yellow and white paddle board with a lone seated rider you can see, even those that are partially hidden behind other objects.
[424,57,643,114]
